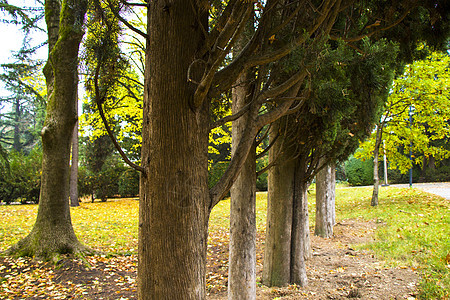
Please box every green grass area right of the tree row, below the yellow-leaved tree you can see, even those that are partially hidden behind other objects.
[330,187,450,299]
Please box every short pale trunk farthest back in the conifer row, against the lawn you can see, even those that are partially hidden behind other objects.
[314,163,336,238]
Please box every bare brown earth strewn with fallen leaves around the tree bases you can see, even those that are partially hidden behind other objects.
[0,219,419,300]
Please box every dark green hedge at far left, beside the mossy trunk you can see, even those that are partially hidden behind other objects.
[0,149,42,204]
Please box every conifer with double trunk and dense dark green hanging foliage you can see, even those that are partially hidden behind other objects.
[263,39,396,286]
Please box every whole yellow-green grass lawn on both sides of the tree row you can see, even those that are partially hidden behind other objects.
[0,187,450,299]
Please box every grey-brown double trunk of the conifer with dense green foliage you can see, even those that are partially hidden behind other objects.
[262,119,309,286]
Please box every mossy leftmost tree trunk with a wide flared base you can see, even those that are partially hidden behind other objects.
[9,0,87,259]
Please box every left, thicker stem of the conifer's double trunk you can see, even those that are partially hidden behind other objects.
[262,119,295,286]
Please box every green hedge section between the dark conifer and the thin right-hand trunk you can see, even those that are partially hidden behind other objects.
[345,156,373,186]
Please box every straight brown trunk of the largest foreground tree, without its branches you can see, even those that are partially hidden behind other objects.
[138,0,211,300]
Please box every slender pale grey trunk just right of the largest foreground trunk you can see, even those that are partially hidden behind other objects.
[228,69,256,300]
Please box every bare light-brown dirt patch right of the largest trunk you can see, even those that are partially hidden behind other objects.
[208,220,419,300]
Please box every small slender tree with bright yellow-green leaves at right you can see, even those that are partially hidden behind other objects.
[356,52,450,206]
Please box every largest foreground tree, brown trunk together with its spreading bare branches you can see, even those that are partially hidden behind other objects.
[82,0,448,299]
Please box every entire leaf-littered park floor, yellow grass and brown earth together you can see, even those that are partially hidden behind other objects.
[0,189,448,299]
